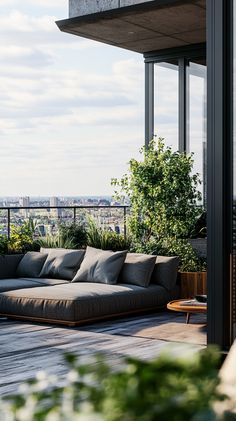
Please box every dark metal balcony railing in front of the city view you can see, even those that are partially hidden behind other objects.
[0,205,129,238]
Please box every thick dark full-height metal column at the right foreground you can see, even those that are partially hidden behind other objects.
[207,0,232,349]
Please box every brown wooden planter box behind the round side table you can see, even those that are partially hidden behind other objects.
[179,272,207,298]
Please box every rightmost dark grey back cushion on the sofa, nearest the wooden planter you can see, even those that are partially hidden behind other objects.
[151,256,179,291]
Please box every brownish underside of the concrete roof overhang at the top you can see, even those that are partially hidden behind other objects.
[57,0,206,53]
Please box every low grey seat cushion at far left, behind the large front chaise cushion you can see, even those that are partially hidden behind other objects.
[0,278,69,293]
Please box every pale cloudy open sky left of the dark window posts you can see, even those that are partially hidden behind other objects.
[0,0,144,196]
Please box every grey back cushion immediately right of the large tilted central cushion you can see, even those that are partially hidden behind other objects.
[118,253,156,288]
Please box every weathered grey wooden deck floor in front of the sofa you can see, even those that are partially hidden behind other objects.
[0,312,206,396]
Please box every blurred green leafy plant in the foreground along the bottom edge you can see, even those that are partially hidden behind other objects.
[0,348,232,421]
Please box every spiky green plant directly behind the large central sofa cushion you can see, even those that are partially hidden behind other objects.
[86,218,130,251]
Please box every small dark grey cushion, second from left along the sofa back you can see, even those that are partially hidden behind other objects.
[16,251,47,278]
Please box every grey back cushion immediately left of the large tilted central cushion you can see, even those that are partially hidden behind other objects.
[40,248,85,281]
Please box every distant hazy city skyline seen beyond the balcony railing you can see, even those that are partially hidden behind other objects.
[0,196,129,237]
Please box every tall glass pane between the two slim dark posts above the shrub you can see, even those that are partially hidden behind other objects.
[154,63,179,150]
